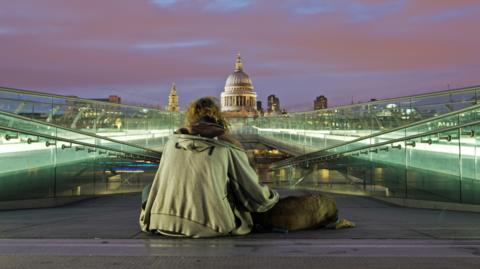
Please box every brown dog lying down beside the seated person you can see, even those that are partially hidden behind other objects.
[252,193,355,232]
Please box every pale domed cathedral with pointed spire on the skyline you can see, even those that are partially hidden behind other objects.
[220,53,257,117]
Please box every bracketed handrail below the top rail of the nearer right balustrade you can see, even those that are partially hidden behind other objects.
[271,120,480,170]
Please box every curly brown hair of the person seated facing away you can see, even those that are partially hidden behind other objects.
[185,96,230,131]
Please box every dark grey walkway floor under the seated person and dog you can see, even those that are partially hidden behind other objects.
[0,189,480,269]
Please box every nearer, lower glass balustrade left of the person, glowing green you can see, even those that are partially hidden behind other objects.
[0,126,160,202]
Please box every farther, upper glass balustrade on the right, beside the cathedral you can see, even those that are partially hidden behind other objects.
[242,87,480,153]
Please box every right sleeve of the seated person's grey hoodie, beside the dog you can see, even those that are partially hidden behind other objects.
[228,149,279,212]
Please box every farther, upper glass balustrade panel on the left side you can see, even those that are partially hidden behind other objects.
[0,88,183,150]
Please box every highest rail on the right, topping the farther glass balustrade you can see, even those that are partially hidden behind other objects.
[260,85,480,115]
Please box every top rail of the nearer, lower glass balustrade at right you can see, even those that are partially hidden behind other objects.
[266,101,480,166]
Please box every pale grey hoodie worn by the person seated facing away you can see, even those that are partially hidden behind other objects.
[140,134,279,237]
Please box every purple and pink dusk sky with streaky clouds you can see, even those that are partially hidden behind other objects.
[0,0,480,111]
